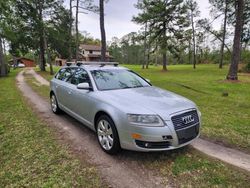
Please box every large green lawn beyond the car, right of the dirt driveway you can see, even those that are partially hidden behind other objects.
[36,65,250,153]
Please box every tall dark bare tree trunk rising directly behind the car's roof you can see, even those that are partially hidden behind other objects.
[99,0,106,61]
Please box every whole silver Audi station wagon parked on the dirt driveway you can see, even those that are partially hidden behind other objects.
[50,62,201,154]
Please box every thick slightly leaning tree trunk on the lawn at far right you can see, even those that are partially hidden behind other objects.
[227,0,244,80]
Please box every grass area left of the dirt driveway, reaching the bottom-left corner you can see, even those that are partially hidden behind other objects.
[0,71,102,187]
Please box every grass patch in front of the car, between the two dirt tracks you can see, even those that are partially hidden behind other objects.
[135,147,250,188]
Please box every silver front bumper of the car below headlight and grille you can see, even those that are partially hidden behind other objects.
[120,121,200,152]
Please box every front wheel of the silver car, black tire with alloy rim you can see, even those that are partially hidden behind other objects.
[96,115,121,155]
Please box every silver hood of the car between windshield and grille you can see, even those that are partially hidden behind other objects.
[96,86,196,120]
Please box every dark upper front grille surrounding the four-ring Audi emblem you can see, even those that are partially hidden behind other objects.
[171,110,199,131]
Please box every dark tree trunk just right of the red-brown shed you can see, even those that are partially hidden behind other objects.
[38,1,46,71]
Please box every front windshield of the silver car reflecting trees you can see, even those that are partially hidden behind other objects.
[91,69,150,90]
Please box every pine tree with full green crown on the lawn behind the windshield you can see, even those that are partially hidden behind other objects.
[133,0,189,71]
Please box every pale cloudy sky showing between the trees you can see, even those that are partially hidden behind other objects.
[65,0,220,40]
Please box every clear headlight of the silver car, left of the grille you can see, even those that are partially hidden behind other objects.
[128,114,164,127]
